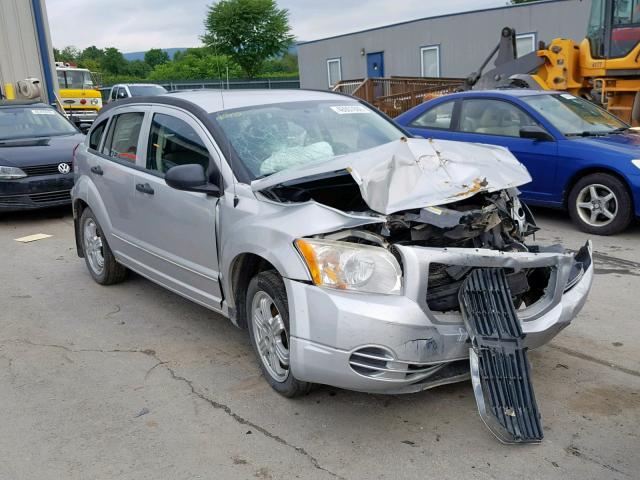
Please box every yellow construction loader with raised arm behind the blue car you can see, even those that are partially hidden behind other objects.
[464,0,640,126]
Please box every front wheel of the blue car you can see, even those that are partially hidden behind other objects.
[568,173,633,235]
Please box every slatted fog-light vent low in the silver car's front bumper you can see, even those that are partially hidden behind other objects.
[349,347,442,380]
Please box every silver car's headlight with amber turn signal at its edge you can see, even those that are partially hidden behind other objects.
[295,238,402,295]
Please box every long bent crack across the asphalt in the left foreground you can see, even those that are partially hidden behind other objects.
[2,339,346,480]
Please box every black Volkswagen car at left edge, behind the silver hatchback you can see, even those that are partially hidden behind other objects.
[0,101,84,212]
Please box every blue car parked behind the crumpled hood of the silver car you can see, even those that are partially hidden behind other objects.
[396,89,640,235]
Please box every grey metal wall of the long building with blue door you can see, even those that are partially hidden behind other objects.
[298,0,591,89]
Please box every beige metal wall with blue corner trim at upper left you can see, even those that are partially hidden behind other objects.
[0,0,57,101]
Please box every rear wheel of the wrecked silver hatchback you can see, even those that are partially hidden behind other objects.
[80,207,127,285]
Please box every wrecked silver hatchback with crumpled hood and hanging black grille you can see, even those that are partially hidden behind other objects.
[72,90,593,442]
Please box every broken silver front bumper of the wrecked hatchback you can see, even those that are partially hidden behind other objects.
[285,245,593,393]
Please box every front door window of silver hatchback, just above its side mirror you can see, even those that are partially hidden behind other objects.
[147,113,209,174]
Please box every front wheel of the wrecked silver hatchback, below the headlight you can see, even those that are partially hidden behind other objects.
[246,270,311,398]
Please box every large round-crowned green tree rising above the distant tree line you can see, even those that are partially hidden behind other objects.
[202,0,294,78]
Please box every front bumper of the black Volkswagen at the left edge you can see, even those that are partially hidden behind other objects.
[0,172,73,212]
